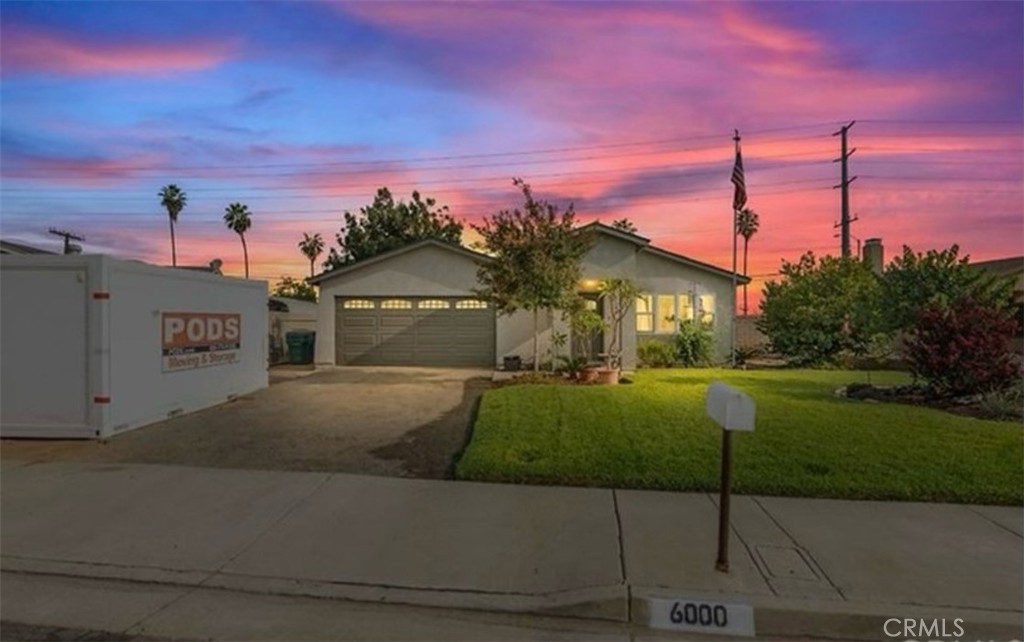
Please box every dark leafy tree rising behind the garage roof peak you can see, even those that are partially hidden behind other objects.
[324,187,462,268]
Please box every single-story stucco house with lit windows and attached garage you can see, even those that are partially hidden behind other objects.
[310,223,744,370]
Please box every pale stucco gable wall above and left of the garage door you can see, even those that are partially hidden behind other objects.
[315,245,479,365]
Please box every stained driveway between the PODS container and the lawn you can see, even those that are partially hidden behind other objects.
[0,368,490,479]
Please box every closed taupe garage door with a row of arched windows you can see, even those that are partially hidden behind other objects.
[335,297,495,368]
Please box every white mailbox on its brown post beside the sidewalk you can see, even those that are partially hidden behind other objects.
[707,381,755,572]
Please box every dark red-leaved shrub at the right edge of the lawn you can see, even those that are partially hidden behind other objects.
[906,298,1018,396]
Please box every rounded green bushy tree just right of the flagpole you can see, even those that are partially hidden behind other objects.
[758,252,880,366]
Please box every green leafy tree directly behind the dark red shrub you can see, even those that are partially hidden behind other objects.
[882,245,1013,332]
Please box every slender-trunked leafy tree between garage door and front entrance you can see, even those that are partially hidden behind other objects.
[473,178,591,371]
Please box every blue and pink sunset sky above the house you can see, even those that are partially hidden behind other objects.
[0,0,1024,307]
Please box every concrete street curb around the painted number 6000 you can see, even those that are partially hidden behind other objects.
[2,556,1024,641]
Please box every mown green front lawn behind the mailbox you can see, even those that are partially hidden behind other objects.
[456,370,1024,505]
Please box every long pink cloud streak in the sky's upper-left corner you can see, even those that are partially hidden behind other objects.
[0,25,233,76]
